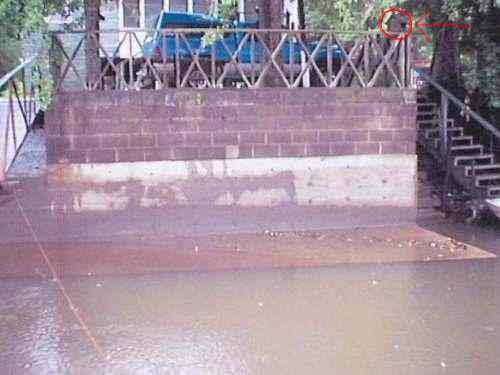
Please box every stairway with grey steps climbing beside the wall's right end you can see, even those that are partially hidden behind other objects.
[417,93,500,212]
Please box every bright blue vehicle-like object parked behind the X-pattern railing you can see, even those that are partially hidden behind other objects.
[139,11,343,86]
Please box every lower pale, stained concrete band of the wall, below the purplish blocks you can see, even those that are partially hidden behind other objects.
[49,155,416,228]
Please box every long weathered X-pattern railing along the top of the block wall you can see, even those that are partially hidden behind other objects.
[52,29,412,90]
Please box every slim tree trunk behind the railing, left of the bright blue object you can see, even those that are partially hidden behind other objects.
[85,0,101,88]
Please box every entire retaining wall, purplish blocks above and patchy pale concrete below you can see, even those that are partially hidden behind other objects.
[47,89,417,233]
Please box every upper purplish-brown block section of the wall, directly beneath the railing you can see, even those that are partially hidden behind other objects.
[46,88,416,164]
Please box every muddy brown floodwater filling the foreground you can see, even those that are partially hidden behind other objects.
[0,217,500,375]
